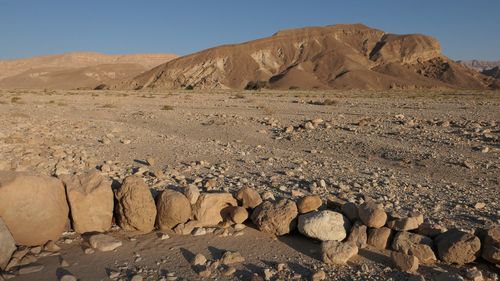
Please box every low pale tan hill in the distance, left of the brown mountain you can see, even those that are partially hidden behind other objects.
[0,52,177,89]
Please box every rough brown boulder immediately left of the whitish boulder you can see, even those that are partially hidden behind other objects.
[251,199,298,236]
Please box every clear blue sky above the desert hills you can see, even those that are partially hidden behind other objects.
[0,0,500,60]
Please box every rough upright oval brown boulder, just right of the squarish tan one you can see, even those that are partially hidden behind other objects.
[115,176,156,233]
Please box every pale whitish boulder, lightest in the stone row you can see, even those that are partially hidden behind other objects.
[298,210,350,241]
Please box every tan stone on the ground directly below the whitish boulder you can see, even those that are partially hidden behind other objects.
[321,241,358,265]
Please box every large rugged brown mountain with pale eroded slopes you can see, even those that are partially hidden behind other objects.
[110,24,498,89]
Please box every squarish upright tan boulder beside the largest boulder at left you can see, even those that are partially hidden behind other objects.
[62,172,113,233]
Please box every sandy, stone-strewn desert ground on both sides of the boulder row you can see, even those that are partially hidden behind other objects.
[0,90,500,280]
